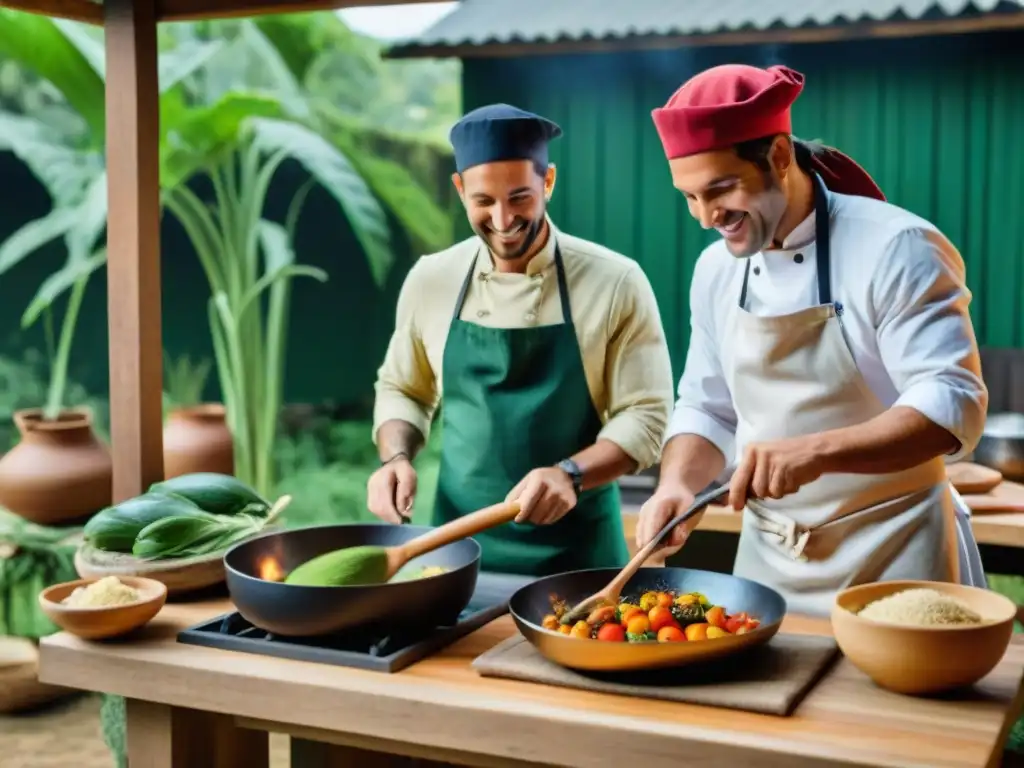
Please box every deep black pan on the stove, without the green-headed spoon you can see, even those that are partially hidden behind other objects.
[224,523,480,637]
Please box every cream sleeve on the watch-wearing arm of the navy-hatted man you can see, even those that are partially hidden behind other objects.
[598,266,672,471]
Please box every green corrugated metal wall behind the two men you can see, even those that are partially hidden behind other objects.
[463,34,1024,374]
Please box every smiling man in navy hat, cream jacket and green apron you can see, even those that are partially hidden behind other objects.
[368,104,673,575]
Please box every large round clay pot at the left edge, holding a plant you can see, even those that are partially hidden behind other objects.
[0,409,114,525]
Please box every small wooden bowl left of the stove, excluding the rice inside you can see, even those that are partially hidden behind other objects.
[39,577,167,640]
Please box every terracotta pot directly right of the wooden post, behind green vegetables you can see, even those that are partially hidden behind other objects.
[164,402,234,478]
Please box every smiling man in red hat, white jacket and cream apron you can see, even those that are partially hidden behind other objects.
[637,65,988,615]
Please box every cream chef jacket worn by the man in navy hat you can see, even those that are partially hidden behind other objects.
[373,219,674,471]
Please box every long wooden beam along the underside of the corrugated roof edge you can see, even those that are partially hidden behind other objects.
[384,10,1024,58]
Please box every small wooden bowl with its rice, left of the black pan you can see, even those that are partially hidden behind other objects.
[39,575,167,640]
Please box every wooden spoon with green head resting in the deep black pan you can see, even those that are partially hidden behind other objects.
[285,502,519,587]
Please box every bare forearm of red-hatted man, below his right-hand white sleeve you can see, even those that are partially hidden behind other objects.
[815,406,959,474]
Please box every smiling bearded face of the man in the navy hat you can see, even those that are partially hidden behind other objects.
[452,160,555,261]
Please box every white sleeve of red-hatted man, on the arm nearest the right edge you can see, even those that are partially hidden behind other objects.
[871,229,988,460]
